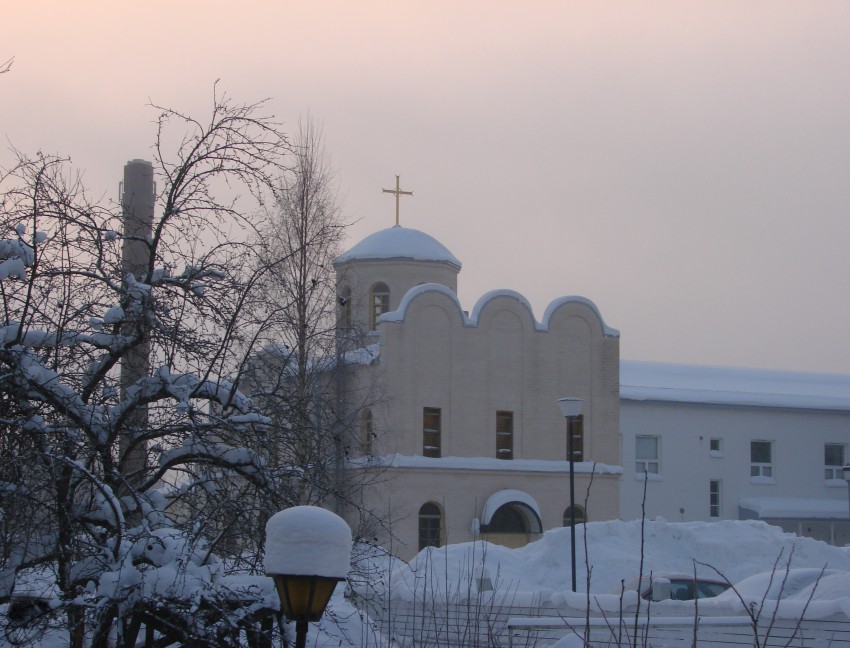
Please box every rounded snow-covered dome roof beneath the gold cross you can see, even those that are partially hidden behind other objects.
[334,225,461,270]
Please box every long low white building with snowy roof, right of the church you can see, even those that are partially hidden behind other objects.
[620,361,850,545]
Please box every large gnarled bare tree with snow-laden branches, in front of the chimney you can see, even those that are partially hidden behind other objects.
[0,90,288,646]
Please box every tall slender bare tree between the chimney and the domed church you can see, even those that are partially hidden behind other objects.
[242,118,380,532]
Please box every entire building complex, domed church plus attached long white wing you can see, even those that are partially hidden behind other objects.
[326,216,850,559]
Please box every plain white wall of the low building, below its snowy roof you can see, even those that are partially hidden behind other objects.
[620,394,850,544]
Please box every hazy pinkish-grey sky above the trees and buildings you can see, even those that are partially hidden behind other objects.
[0,0,850,373]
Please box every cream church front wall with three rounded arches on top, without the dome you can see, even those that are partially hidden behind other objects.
[342,284,620,558]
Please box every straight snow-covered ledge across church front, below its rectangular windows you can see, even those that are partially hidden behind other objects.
[346,454,623,475]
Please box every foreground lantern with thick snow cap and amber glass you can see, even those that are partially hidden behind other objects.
[264,506,351,648]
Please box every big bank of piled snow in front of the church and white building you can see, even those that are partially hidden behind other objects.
[388,518,850,609]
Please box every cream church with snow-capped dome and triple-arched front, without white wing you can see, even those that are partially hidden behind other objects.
[334,225,621,559]
